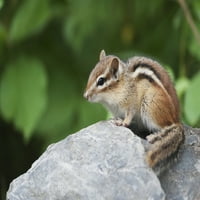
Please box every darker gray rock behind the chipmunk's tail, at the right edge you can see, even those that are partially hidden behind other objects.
[159,127,200,200]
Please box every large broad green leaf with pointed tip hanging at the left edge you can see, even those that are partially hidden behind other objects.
[0,56,47,139]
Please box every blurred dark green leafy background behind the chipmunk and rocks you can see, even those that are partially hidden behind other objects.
[0,0,200,199]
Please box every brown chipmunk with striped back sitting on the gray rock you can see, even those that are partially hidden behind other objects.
[84,50,184,168]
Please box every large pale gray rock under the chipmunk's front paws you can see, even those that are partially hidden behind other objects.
[7,122,165,200]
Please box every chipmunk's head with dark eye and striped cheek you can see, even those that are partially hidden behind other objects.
[84,50,124,103]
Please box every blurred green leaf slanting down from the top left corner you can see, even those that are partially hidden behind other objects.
[9,0,51,42]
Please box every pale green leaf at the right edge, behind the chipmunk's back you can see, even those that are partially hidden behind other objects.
[184,72,200,125]
